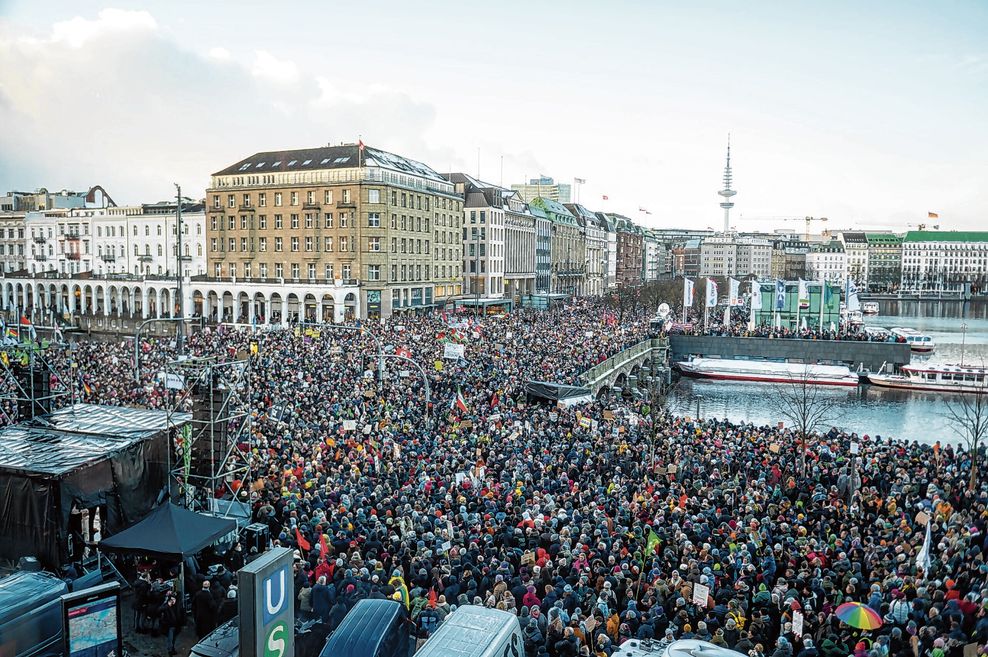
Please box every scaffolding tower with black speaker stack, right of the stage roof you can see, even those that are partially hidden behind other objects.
[164,354,252,520]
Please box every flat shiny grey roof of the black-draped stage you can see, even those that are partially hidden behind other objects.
[0,404,192,478]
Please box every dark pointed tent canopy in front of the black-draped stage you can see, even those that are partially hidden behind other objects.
[100,502,237,559]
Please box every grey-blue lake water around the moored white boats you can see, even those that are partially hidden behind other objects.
[669,301,988,443]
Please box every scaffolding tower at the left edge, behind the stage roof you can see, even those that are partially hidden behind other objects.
[0,339,74,424]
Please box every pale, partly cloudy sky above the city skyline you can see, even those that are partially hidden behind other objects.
[0,0,988,231]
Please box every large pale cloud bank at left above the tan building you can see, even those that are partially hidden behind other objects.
[0,10,455,203]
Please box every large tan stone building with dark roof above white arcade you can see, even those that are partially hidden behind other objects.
[206,144,464,318]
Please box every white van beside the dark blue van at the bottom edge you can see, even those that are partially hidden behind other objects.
[415,605,525,657]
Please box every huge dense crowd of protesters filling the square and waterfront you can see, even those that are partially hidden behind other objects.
[15,300,988,657]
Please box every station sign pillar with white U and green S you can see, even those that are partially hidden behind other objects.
[237,548,295,657]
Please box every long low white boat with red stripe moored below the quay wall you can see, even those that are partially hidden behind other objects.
[676,358,858,386]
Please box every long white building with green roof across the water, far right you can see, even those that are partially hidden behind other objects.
[900,230,988,295]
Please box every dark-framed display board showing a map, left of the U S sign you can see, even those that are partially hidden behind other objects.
[62,582,123,657]
